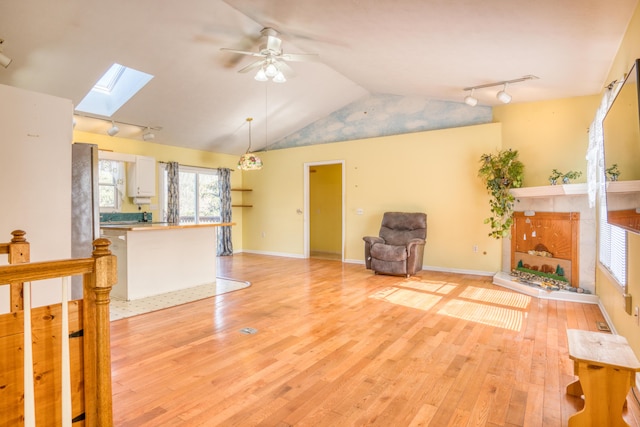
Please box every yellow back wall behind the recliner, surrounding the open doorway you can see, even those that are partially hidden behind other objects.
[243,123,501,272]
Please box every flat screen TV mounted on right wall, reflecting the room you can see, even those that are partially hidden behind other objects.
[602,59,640,233]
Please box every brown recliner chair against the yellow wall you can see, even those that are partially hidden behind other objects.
[362,212,427,277]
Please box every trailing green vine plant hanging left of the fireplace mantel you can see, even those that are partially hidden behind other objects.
[478,149,524,239]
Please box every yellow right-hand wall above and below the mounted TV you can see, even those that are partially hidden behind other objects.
[596,5,640,357]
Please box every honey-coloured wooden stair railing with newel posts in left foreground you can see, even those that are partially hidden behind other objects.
[0,234,117,427]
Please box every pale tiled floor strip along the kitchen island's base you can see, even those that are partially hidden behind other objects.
[109,277,251,321]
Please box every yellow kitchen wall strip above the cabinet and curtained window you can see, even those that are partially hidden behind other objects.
[73,131,243,251]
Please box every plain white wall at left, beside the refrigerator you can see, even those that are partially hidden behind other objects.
[0,85,73,312]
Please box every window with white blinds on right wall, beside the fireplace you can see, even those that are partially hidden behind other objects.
[599,192,627,292]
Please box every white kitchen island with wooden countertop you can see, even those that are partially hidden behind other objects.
[100,222,234,301]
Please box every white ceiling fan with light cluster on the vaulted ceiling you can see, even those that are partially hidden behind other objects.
[220,27,318,83]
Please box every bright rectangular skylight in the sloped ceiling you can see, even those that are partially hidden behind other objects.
[76,64,153,117]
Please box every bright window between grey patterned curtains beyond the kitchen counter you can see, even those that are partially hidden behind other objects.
[160,165,221,224]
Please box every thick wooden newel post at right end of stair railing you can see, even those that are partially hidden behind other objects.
[83,238,118,427]
